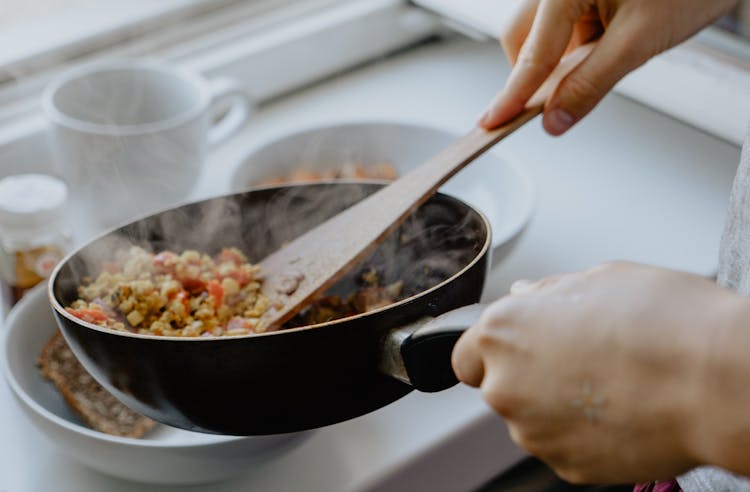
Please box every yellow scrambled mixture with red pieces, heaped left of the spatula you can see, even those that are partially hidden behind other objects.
[66,247,270,337]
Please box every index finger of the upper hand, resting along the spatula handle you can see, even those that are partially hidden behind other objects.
[479,0,588,129]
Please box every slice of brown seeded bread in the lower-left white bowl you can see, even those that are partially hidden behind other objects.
[39,331,156,438]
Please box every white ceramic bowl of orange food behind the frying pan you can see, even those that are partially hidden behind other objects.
[230,122,536,264]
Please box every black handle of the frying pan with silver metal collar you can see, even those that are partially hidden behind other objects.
[380,304,487,393]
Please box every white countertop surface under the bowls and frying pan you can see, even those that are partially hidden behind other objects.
[0,36,739,492]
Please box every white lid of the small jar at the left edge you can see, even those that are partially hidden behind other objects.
[0,174,68,229]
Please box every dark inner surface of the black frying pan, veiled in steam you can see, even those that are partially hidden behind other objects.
[58,183,485,320]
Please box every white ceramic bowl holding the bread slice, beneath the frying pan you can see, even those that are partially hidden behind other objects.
[0,286,310,485]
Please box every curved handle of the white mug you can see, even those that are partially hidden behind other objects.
[208,77,252,147]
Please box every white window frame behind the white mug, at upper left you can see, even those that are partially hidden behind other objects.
[0,0,446,174]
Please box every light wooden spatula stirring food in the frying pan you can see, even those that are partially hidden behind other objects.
[257,45,592,331]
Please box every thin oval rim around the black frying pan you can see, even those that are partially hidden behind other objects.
[47,179,492,343]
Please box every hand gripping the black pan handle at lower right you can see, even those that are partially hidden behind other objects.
[453,263,746,483]
